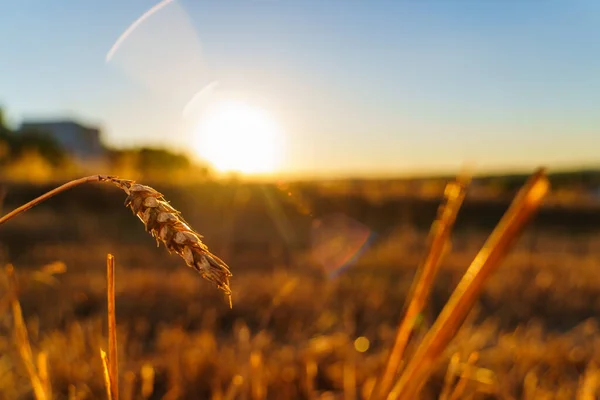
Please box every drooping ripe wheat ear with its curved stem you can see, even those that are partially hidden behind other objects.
[0,175,231,306]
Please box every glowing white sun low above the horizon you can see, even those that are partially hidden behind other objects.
[195,101,283,174]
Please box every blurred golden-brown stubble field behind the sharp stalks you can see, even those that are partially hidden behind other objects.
[0,164,600,399]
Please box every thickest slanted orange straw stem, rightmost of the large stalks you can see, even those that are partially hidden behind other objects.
[388,169,550,400]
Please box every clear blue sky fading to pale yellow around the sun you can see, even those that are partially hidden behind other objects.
[0,0,600,174]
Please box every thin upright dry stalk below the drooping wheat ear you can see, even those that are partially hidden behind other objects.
[106,254,119,400]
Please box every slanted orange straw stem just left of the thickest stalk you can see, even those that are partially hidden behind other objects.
[373,174,471,399]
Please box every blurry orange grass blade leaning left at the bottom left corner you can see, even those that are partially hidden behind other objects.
[6,265,49,400]
